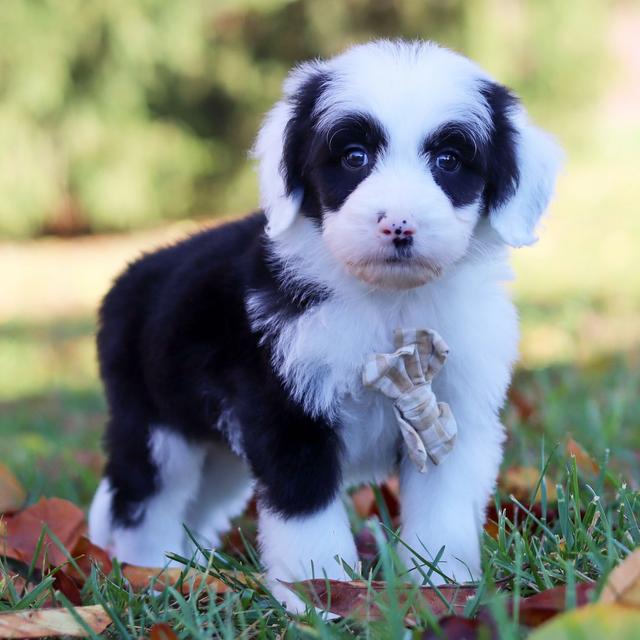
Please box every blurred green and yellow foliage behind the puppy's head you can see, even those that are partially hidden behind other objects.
[0,0,609,237]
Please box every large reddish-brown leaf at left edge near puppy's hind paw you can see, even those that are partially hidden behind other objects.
[0,498,86,566]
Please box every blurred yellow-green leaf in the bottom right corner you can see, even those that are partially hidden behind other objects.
[528,602,640,640]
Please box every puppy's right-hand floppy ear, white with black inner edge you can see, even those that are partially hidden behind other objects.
[481,82,563,247]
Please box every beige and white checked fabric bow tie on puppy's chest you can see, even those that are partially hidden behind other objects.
[362,329,458,473]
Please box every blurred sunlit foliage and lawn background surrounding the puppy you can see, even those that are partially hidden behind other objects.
[0,0,640,503]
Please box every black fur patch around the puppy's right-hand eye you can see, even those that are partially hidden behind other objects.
[422,122,487,207]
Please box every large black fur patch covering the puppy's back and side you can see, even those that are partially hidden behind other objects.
[98,214,341,526]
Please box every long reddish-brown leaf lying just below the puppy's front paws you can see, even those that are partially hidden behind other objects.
[283,579,476,624]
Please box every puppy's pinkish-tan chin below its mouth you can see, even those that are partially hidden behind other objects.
[345,258,441,289]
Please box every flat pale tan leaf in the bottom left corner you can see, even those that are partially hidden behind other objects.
[0,604,111,638]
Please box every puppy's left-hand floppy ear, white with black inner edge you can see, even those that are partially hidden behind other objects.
[253,61,328,237]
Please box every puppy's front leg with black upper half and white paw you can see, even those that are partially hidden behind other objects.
[242,386,357,610]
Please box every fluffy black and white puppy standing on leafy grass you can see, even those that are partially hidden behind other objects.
[90,41,560,607]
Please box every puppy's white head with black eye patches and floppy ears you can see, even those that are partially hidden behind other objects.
[255,41,560,288]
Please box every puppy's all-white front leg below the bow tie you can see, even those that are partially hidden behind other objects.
[398,411,503,584]
